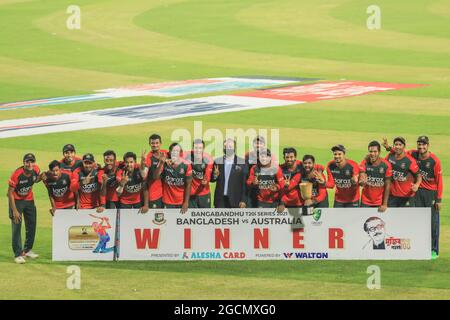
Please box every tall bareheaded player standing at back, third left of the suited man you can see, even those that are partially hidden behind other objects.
[144,134,168,209]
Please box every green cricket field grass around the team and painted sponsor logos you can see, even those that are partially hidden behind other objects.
[0,0,450,299]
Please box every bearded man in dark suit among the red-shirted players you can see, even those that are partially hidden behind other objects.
[211,139,248,208]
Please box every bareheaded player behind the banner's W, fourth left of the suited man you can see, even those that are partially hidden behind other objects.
[116,152,148,213]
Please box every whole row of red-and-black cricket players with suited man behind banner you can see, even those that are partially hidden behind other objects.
[8,134,443,263]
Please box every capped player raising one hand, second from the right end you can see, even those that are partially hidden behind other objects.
[384,137,422,208]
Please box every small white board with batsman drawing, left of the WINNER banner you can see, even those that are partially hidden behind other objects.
[53,209,117,261]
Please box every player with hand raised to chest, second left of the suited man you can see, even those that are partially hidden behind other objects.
[153,143,192,213]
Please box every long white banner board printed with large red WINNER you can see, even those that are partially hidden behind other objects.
[120,208,431,261]
